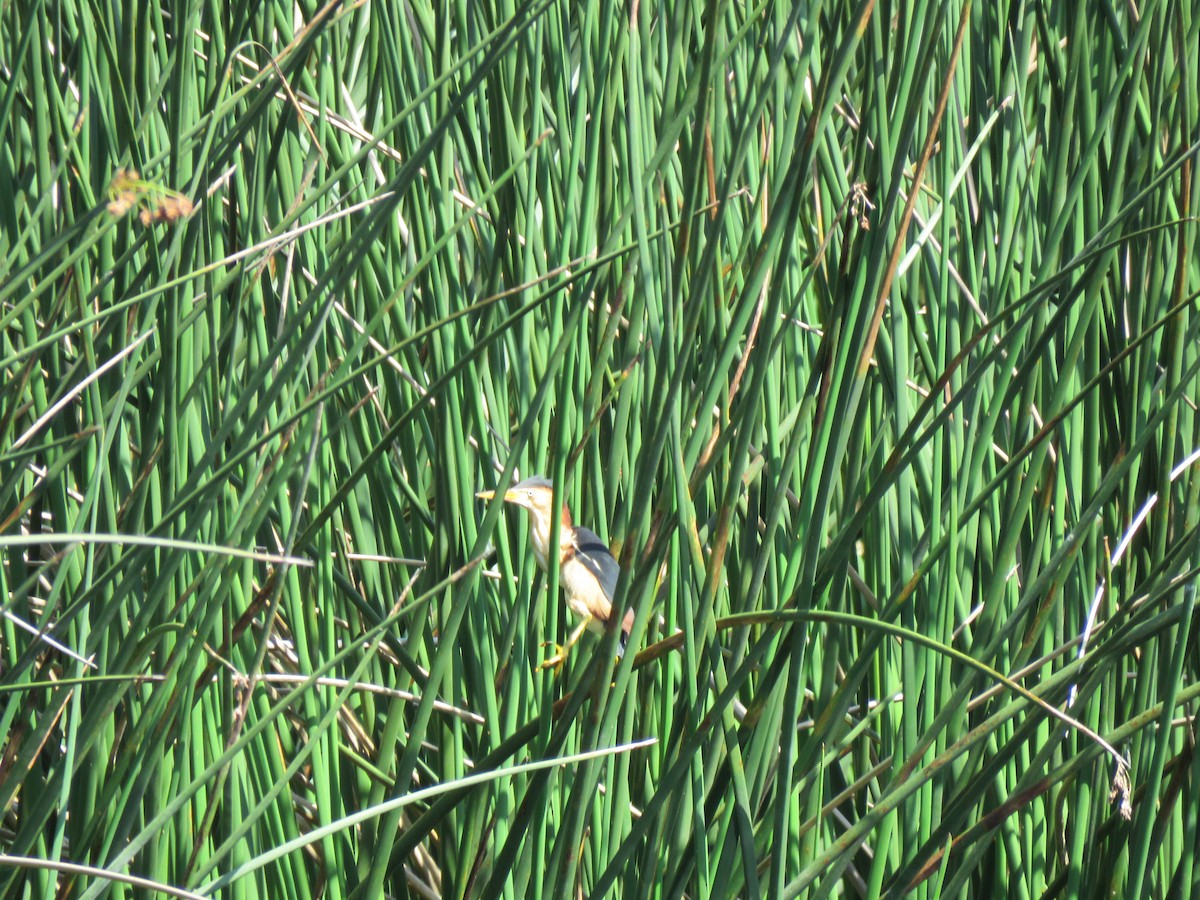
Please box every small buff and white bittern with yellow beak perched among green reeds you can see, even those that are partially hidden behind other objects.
[475,475,634,672]
